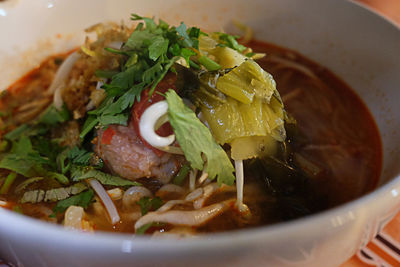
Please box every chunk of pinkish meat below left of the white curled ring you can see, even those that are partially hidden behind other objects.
[95,124,180,183]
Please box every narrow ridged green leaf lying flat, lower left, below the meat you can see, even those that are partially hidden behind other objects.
[71,166,141,186]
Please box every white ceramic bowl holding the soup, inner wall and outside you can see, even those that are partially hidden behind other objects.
[0,0,400,266]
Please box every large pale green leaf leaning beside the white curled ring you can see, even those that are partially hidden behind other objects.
[166,90,235,185]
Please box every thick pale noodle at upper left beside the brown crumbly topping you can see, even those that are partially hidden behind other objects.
[47,52,81,109]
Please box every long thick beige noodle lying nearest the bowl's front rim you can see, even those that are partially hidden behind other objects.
[135,200,234,230]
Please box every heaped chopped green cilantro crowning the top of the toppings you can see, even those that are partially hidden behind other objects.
[80,14,206,139]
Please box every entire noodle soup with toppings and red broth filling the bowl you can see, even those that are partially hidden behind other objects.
[0,15,382,237]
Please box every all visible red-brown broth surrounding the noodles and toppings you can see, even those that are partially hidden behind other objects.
[0,41,382,236]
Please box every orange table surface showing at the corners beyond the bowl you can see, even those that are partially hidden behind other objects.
[0,0,400,267]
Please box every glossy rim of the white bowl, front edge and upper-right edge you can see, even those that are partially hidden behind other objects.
[0,0,400,253]
